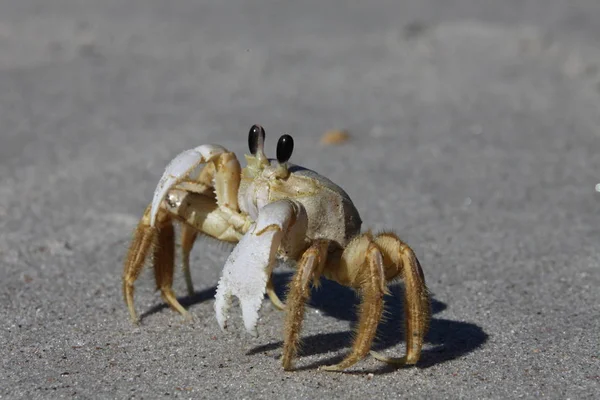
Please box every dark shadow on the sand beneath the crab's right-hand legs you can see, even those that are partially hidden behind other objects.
[247,273,488,374]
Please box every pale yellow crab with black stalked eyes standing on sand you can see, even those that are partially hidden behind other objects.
[123,125,430,371]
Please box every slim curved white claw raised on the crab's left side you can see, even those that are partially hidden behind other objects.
[150,144,227,226]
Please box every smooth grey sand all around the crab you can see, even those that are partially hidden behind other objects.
[0,0,600,399]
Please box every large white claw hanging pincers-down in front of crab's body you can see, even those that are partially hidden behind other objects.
[215,200,306,336]
